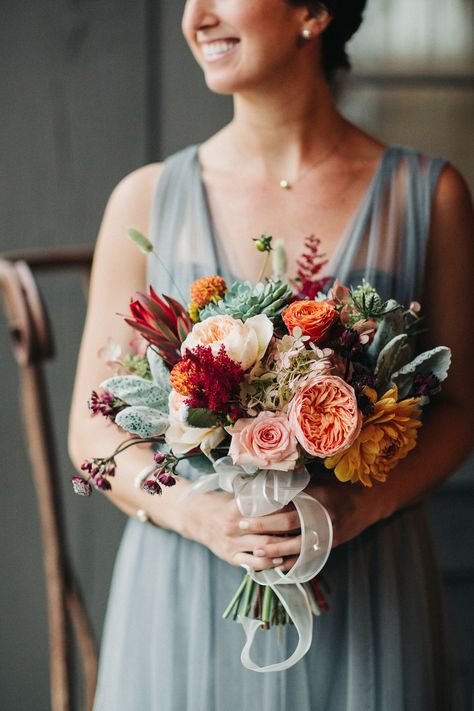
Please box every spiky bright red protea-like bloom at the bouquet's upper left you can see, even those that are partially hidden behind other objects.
[125,286,193,366]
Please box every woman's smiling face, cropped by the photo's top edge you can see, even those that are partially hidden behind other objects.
[182,0,314,94]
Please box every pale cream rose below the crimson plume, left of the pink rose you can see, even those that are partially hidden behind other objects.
[165,390,225,454]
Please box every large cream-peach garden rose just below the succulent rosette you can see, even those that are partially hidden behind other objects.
[181,314,273,370]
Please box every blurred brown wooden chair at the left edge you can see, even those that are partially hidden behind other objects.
[0,247,97,711]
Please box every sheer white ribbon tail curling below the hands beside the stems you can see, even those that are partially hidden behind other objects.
[238,583,313,672]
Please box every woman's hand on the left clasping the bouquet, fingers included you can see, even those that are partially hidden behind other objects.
[182,492,301,571]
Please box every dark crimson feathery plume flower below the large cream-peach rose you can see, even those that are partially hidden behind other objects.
[185,345,244,415]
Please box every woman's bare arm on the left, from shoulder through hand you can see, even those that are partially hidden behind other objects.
[69,165,294,570]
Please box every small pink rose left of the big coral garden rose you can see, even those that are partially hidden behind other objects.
[226,412,298,472]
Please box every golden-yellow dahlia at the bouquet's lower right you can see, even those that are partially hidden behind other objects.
[324,386,421,486]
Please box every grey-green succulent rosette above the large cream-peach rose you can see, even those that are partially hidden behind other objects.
[200,279,293,321]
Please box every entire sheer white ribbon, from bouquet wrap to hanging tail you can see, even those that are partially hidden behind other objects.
[181,457,332,672]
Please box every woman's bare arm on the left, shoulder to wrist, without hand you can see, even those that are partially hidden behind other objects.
[69,164,193,528]
